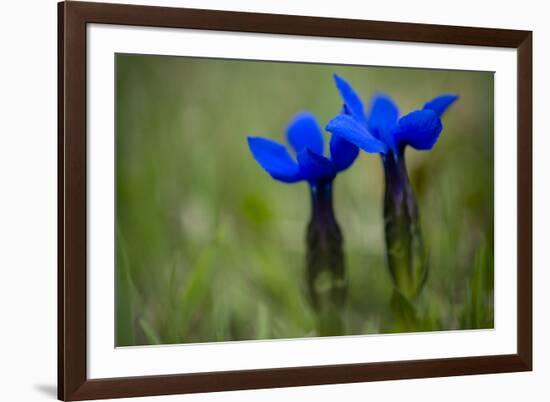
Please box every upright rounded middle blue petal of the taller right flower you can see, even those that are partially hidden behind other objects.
[367,94,399,148]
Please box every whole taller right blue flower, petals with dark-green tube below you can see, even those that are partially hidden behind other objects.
[326,75,458,304]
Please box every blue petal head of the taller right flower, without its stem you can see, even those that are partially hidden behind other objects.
[326,75,458,156]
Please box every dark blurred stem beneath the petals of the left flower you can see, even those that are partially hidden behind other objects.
[306,182,347,335]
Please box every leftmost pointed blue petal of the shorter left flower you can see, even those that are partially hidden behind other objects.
[248,137,304,183]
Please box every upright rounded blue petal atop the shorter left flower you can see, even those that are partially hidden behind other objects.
[286,112,324,155]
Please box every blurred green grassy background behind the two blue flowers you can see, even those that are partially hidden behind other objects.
[116,54,493,346]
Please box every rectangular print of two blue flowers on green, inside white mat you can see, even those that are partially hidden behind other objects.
[115,54,494,346]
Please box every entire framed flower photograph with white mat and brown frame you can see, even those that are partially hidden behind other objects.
[58,1,532,400]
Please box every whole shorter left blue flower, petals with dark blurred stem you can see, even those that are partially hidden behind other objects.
[248,112,359,336]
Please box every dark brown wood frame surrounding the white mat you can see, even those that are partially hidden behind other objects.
[58,1,532,400]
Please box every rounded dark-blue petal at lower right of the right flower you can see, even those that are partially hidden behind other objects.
[396,109,443,150]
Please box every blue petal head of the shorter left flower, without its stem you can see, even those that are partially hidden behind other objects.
[248,112,359,185]
